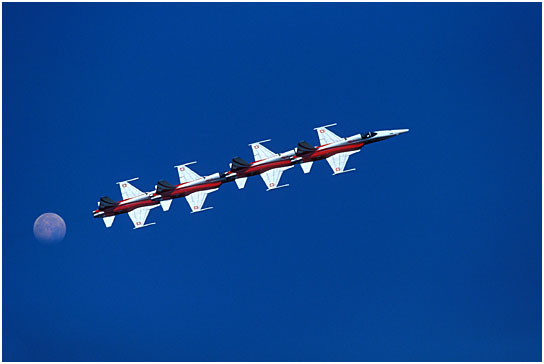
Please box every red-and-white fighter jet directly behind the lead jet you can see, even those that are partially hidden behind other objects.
[227,139,296,191]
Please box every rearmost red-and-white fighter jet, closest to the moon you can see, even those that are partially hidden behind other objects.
[93,178,159,229]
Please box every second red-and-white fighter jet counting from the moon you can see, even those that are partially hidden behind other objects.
[151,162,234,213]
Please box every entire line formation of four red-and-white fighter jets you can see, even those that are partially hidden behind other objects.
[93,124,409,229]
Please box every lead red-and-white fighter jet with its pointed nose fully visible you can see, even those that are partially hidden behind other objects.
[295,123,409,175]
